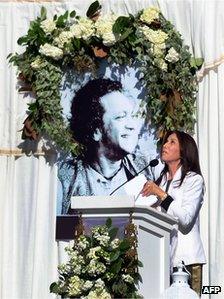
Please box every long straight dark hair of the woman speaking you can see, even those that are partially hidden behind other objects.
[156,130,202,186]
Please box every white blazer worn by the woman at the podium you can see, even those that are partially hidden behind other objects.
[160,167,206,267]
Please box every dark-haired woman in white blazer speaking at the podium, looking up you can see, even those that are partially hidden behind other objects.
[141,131,206,294]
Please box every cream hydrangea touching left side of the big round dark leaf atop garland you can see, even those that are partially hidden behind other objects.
[95,15,117,46]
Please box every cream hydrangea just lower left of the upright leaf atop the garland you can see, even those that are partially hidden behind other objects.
[70,17,94,40]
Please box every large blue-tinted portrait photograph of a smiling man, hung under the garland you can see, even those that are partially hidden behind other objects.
[58,65,158,214]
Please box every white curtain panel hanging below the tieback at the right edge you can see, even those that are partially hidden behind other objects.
[197,64,224,298]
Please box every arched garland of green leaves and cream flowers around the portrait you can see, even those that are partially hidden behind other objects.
[8,1,202,155]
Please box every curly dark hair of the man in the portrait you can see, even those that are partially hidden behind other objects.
[70,78,122,146]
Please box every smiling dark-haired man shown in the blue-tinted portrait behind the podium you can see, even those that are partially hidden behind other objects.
[59,78,154,214]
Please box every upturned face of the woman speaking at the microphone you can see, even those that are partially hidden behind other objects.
[161,133,180,164]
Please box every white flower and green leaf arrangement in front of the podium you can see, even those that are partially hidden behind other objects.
[50,218,142,299]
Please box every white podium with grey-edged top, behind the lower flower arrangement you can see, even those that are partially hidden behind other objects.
[65,196,176,299]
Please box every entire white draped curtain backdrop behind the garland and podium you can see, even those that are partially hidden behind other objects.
[0,0,224,299]
